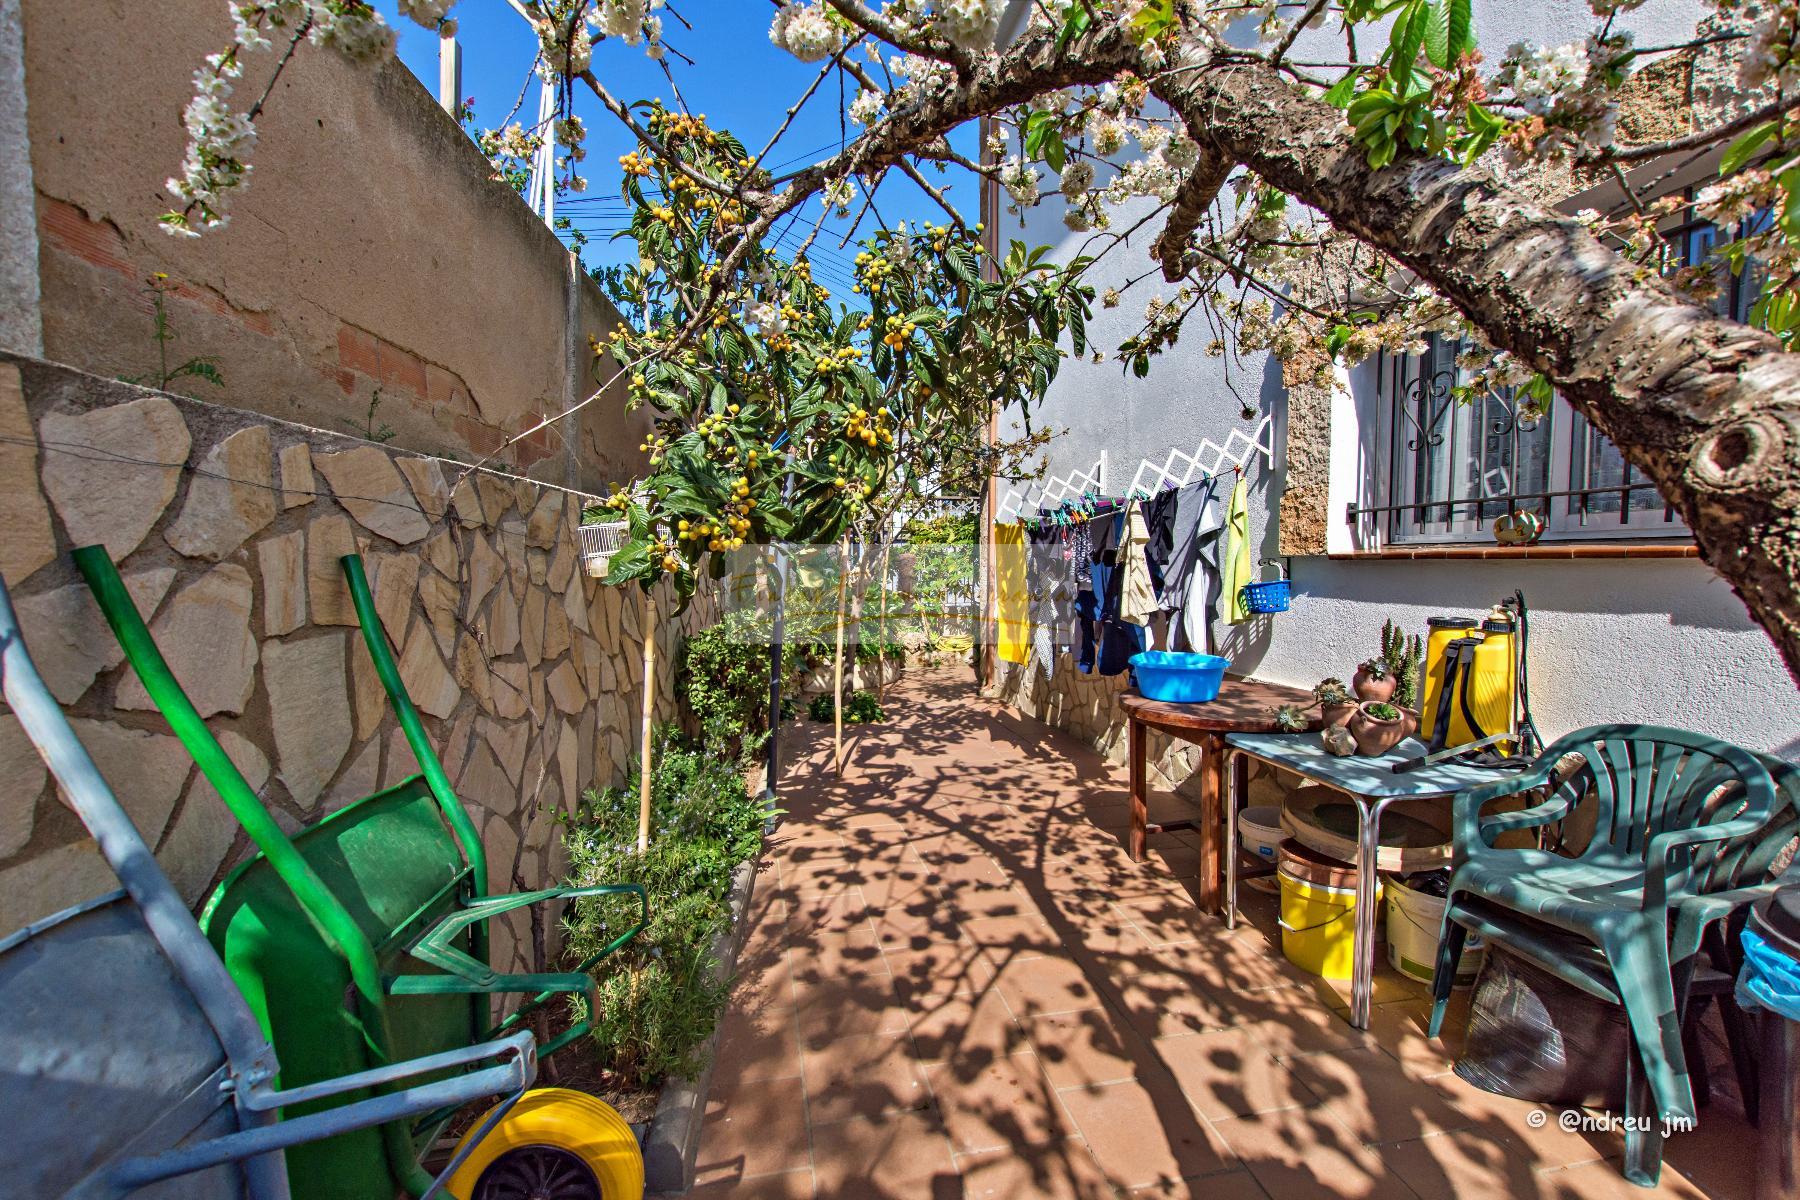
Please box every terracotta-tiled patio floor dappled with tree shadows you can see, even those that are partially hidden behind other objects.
[695,671,1755,1200]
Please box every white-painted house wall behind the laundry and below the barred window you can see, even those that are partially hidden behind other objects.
[988,0,1800,770]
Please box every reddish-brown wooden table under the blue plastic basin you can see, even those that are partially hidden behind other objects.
[1120,676,1312,912]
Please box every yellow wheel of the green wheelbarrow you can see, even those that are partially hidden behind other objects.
[446,1087,644,1200]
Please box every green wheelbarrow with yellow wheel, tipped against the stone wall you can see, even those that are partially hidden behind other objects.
[76,547,648,1200]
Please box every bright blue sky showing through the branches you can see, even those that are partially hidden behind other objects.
[376,0,979,300]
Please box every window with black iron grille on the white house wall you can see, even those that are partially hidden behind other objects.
[1350,205,1760,545]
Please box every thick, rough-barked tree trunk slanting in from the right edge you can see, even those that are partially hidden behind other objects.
[1152,61,1800,680]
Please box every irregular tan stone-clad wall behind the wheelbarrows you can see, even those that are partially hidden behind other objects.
[0,356,715,968]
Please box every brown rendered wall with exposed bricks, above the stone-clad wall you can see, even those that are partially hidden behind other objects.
[15,0,648,491]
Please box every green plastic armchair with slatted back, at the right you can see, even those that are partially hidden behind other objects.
[1429,725,1800,1187]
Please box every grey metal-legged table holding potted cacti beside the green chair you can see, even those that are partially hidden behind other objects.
[1226,732,1503,1029]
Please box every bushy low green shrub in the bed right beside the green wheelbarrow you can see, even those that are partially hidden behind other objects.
[563,727,769,1088]
